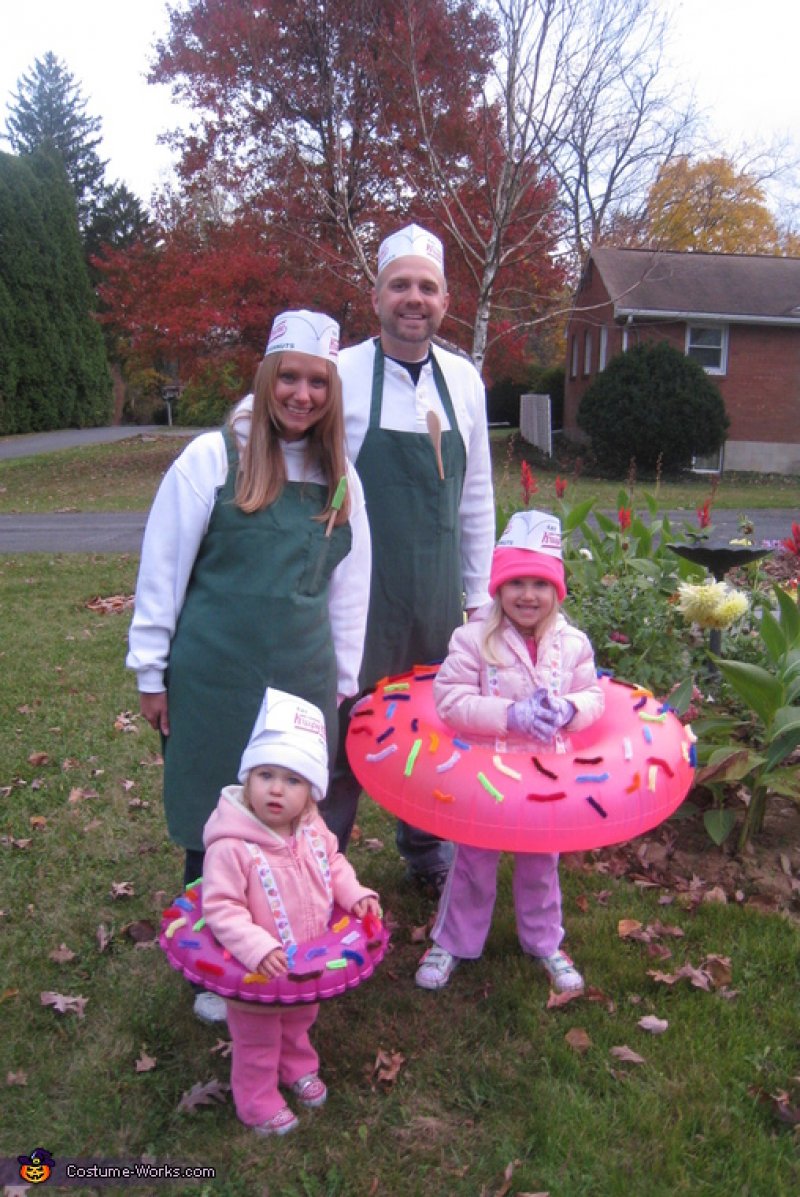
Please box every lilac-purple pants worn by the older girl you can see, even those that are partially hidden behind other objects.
[431,844,564,960]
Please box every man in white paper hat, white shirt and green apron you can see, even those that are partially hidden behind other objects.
[320,224,495,894]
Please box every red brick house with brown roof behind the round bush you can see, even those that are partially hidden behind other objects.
[564,247,800,474]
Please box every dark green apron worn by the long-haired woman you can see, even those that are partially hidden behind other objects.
[164,430,352,850]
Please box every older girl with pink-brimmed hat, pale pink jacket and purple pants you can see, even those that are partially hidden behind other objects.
[416,511,604,992]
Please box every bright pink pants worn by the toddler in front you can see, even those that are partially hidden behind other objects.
[228,1002,320,1126]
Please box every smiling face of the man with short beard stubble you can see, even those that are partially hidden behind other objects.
[372,256,449,361]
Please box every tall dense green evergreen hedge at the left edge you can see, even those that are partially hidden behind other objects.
[0,150,111,433]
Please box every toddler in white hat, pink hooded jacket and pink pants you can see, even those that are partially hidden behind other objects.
[202,689,380,1135]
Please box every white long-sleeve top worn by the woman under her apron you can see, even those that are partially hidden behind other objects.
[126,396,371,699]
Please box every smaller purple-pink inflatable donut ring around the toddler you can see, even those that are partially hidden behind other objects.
[158,895,389,1005]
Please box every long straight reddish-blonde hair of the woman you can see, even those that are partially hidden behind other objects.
[230,353,350,524]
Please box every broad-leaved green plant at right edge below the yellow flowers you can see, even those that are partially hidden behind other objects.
[696,587,800,847]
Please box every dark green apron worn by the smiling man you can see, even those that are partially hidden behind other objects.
[356,341,467,687]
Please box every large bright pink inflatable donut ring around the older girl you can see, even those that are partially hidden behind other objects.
[346,666,696,852]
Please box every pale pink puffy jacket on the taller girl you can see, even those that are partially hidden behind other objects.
[434,603,604,752]
